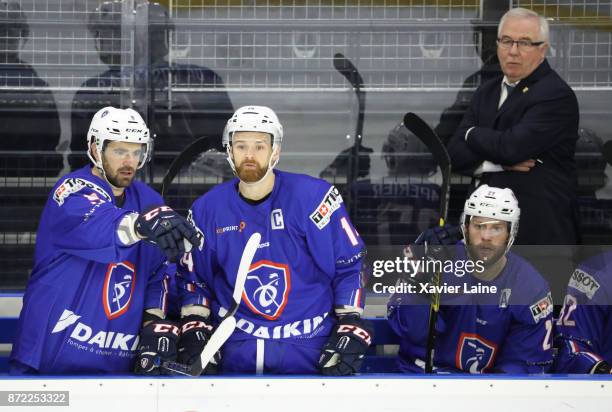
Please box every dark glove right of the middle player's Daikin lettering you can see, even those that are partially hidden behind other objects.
[319,315,373,376]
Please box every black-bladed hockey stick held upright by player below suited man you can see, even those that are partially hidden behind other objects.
[404,113,451,373]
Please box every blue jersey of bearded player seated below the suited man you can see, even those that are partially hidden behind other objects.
[388,242,553,373]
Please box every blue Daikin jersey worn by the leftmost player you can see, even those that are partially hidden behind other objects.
[11,167,167,374]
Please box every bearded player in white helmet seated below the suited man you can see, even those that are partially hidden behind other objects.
[388,185,553,373]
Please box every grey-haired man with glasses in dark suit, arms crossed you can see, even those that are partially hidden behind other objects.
[448,8,579,245]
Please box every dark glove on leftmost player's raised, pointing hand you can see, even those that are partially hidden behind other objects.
[134,206,201,262]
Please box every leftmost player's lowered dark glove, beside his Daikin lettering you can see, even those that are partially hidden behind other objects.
[134,319,180,375]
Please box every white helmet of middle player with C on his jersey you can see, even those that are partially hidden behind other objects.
[222,106,283,148]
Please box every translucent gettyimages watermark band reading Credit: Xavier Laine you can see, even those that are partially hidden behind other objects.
[365,243,612,307]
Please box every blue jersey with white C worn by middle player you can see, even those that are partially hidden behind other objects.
[178,170,365,348]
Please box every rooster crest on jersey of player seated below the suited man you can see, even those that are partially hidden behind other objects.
[455,332,497,373]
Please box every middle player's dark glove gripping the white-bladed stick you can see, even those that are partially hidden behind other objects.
[178,315,221,375]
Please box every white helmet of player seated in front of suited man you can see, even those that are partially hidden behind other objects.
[461,185,521,252]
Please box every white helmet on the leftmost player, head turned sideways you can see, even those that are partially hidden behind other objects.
[87,106,152,169]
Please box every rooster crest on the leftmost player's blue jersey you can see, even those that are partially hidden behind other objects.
[102,262,136,319]
